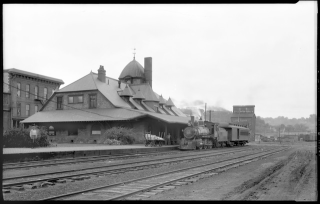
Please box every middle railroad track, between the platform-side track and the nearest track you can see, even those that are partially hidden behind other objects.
[2,148,268,190]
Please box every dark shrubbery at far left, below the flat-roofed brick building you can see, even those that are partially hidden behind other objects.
[3,127,51,147]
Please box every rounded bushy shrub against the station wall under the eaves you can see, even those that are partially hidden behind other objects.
[104,127,135,144]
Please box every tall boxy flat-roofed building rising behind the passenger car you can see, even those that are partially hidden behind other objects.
[231,105,256,141]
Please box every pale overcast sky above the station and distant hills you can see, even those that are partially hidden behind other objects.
[3,1,317,118]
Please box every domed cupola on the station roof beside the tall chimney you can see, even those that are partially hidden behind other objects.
[119,59,145,84]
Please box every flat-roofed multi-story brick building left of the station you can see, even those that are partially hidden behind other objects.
[3,68,64,130]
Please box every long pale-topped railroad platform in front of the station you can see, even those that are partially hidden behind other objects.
[2,144,178,163]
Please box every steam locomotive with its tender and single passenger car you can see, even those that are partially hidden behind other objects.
[179,117,250,150]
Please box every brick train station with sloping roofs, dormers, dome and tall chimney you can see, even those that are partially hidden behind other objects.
[22,57,190,144]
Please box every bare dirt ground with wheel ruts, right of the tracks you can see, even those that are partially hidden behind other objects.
[143,143,317,201]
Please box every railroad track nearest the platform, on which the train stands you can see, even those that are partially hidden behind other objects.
[3,146,249,171]
